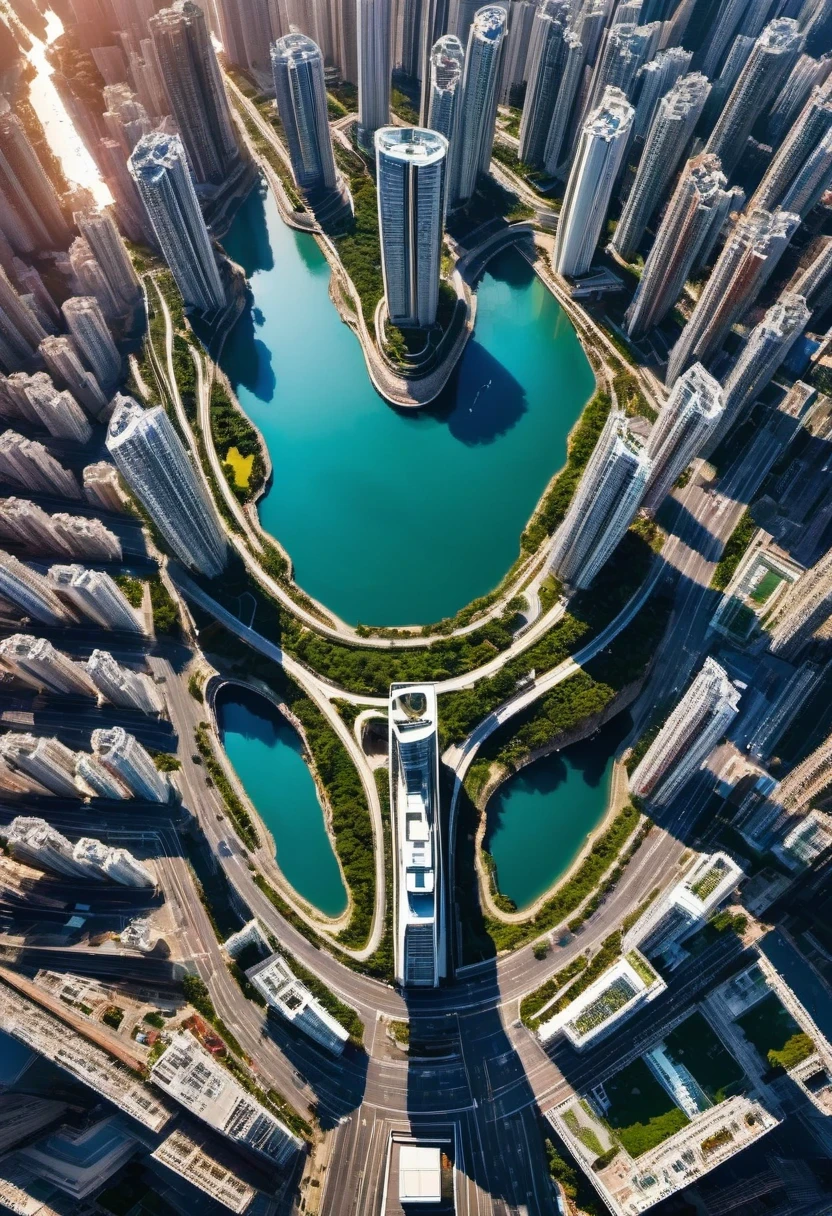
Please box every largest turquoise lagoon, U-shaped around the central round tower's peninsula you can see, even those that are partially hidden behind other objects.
[223,192,595,625]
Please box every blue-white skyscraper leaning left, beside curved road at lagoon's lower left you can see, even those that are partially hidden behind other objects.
[107,396,227,578]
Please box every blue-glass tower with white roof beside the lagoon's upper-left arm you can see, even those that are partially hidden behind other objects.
[128,131,226,313]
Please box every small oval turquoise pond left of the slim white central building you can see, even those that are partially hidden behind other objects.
[217,685,347,917]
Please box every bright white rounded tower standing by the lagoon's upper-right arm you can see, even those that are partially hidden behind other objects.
[553,88,634,276]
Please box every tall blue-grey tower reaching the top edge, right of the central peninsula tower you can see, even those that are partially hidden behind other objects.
[457,5,506,203]
